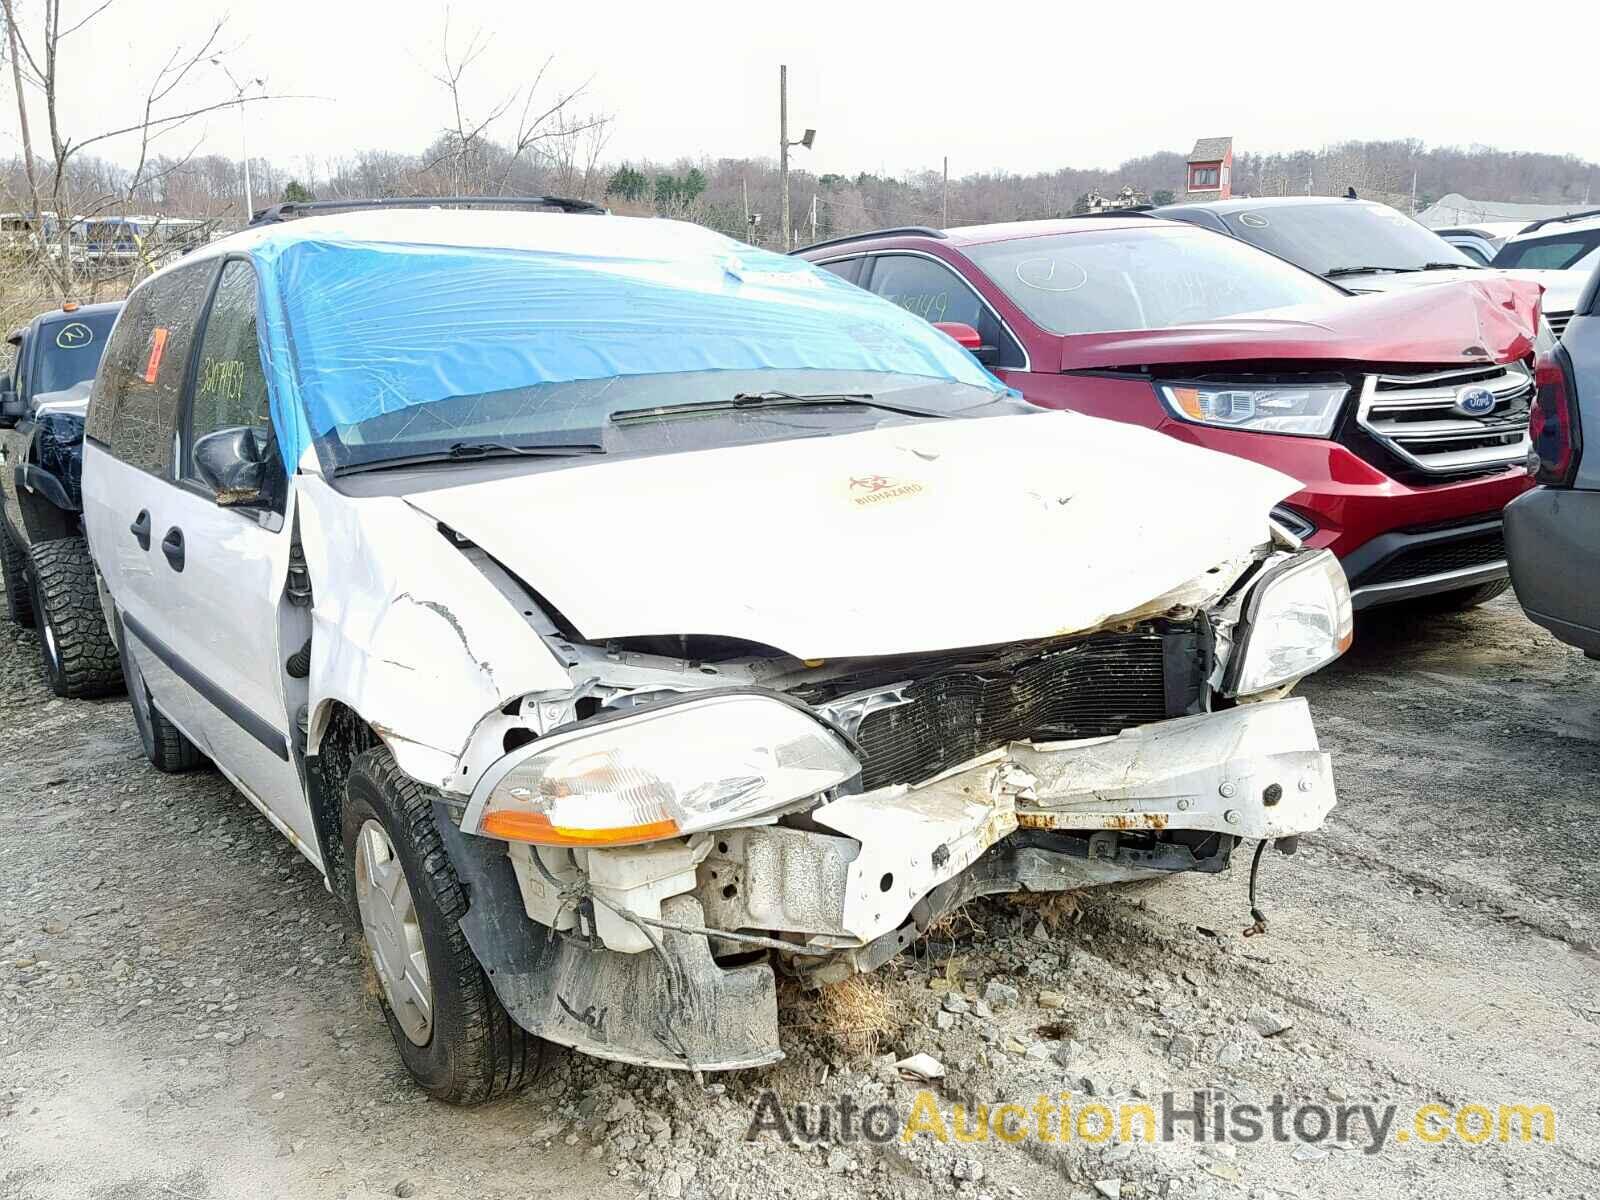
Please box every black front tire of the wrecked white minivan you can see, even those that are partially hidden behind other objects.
[339,747,546,1104]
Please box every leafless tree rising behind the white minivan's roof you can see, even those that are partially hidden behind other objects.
[424,10,611,195]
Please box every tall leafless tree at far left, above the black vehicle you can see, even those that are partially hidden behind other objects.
[0,0,267,298]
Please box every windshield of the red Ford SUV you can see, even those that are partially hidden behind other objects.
[965,224,1344,333]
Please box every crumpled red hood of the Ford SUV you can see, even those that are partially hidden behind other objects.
[1061,270,1558,371]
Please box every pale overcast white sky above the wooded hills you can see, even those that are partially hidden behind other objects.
[18,0,1600,176]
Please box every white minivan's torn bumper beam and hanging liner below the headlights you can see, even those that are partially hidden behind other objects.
[457,699,1334,1070]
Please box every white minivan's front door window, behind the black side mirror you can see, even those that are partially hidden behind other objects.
[181,259,286,512]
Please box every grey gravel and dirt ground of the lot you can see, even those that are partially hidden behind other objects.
[0,597,1600,1200]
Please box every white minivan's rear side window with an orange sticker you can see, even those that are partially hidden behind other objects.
[98,262,216,478]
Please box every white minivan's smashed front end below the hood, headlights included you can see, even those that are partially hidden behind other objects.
[437,538,1350,1069]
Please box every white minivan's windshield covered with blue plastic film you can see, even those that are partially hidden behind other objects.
[258,225,1005,467]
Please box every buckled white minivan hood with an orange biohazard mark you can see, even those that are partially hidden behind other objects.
[406,411,1299,659]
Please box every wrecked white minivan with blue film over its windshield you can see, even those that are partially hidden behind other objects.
[83,206,1350,1102]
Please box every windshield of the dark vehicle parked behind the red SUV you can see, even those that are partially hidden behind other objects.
[1218,200,1477,275]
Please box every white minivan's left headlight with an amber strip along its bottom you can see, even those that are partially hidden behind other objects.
[462,693,861,846]
